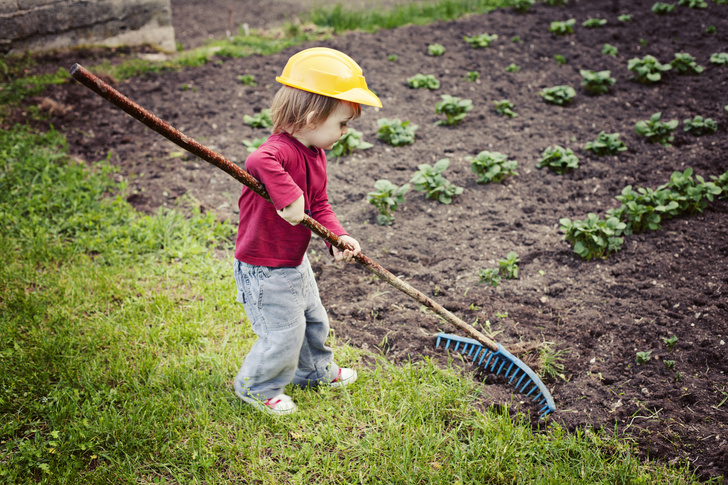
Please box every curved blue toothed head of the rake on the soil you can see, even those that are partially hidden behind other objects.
[435,333,556,417]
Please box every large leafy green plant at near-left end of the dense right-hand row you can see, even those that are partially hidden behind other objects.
[559,212,627,261]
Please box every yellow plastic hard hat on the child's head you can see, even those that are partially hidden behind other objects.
[276,47,382,108]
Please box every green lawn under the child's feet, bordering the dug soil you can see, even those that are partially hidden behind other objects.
[0,122,712,484]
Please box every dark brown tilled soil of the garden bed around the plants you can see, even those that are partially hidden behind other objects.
[17,0,728,478]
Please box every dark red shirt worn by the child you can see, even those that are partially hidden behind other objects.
[235,133,347,267]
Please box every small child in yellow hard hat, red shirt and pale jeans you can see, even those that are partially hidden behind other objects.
[234,47,382,414]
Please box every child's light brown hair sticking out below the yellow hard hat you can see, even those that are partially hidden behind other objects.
[270,86,361,135]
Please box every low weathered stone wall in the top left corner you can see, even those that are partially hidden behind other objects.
[0,0,175,53]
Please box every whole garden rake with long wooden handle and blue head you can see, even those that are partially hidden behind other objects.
[69,64,556,417]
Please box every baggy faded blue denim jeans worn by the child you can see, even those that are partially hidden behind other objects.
[234,256,339,400]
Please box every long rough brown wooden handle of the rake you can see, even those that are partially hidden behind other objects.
[69,64,498,351]
